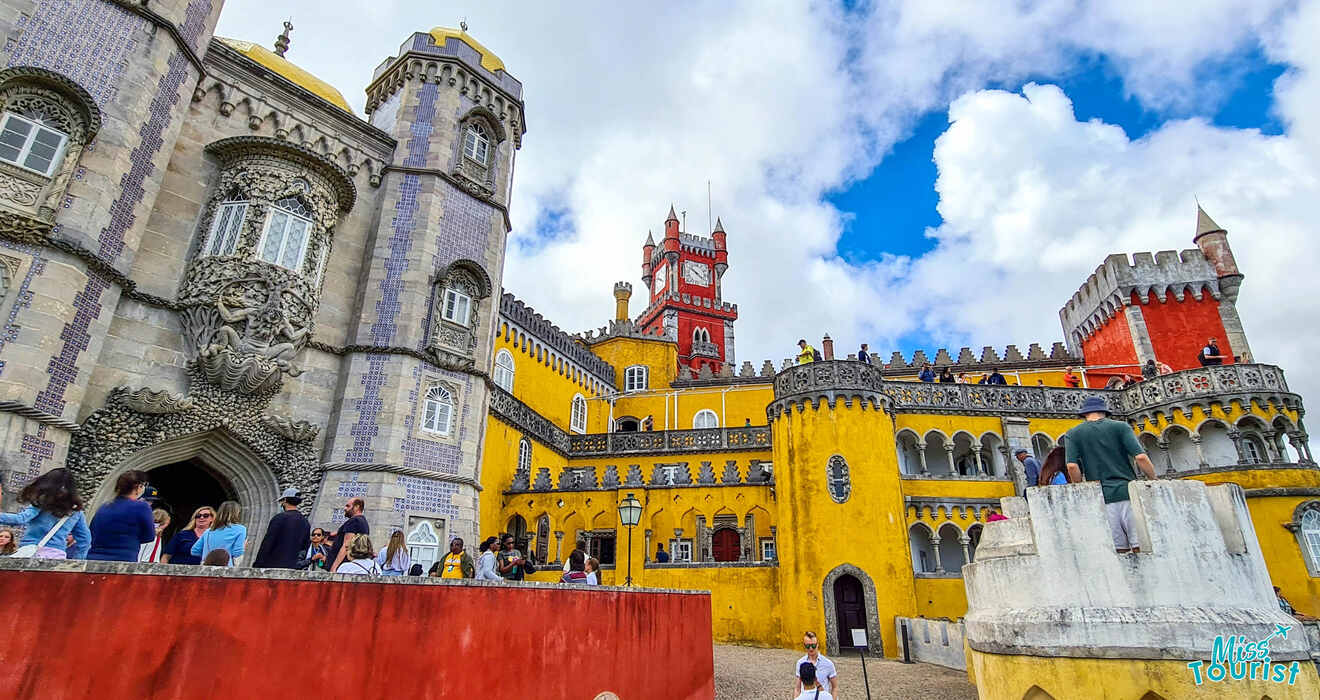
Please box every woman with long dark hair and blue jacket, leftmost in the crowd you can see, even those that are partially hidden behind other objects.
[0,469,90,559]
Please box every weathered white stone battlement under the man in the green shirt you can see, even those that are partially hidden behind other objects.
[962,481,1309,663]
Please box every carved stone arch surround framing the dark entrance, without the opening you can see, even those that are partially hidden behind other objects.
[90,429,280,554]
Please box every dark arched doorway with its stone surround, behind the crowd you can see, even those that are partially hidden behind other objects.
[88,429,283,564]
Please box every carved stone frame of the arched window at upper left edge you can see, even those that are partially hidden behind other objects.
[0,66,102,222]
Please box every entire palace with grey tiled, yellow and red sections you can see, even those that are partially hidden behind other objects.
[0,0,1320,656]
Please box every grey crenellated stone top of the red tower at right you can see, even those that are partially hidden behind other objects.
[1059,248,1222,348]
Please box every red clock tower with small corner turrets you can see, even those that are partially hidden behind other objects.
[636,206,738,374]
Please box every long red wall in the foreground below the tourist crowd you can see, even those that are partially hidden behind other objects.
[0,571,714,700]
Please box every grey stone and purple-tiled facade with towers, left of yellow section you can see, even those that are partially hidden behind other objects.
[0,0,524,545]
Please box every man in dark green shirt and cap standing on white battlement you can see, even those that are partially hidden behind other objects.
[1063,396,1155,553]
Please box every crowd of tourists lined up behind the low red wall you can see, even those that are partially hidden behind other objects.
[0,469,601,585]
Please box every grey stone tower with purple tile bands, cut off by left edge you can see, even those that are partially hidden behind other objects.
[0,0,223,491]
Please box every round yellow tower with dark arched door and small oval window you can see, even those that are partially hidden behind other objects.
[768,362,916,655]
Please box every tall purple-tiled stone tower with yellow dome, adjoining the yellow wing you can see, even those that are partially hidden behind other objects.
[317,28,524,542]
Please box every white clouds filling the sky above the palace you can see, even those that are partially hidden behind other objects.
[220,0,1320,398]
